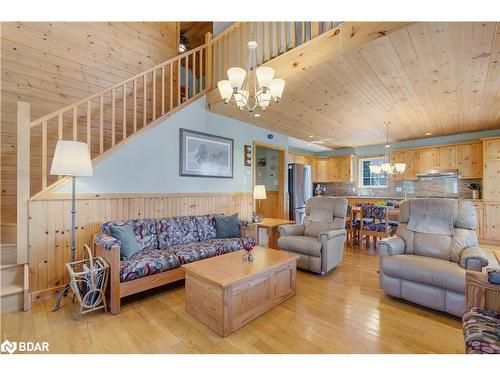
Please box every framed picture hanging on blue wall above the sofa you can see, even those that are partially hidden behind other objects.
[179,129,234,178]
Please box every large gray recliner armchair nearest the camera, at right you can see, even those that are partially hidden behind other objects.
[378,198,488,316]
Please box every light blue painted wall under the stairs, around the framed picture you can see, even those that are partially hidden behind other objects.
[59,96,288,193]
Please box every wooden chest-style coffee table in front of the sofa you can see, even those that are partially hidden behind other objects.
[182,246,298,336]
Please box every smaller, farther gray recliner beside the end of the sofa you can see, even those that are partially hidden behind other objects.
[278,197,347,275]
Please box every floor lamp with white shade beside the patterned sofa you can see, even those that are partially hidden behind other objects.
[50,141,92,311]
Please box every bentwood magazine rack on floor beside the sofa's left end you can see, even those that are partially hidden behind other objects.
[66,245,109,316]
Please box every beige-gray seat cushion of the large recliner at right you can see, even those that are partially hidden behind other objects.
[382,255,465,293]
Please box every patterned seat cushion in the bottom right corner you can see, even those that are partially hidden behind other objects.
[462,307,500,354]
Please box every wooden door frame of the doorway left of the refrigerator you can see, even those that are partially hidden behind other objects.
[252,140,288,219]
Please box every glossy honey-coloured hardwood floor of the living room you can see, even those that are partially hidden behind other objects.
[1,248,496,353]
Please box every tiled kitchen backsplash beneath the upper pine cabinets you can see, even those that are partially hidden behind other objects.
[321,177,482,199]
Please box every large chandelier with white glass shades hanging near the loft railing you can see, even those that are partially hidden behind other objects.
[217,39,285,117]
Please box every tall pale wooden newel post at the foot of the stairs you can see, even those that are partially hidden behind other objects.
[17,102,31,264]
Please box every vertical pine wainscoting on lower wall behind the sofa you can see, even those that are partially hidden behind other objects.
[29,192,253,300]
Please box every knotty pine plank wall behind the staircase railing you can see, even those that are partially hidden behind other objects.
[0,22,179,242]
